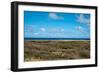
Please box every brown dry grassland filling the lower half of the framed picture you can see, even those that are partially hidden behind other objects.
[24,41,90,61]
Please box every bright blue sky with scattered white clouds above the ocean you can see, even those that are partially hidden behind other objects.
[24,11,90,38]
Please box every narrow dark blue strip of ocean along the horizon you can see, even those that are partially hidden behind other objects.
[24,38,90,40]
